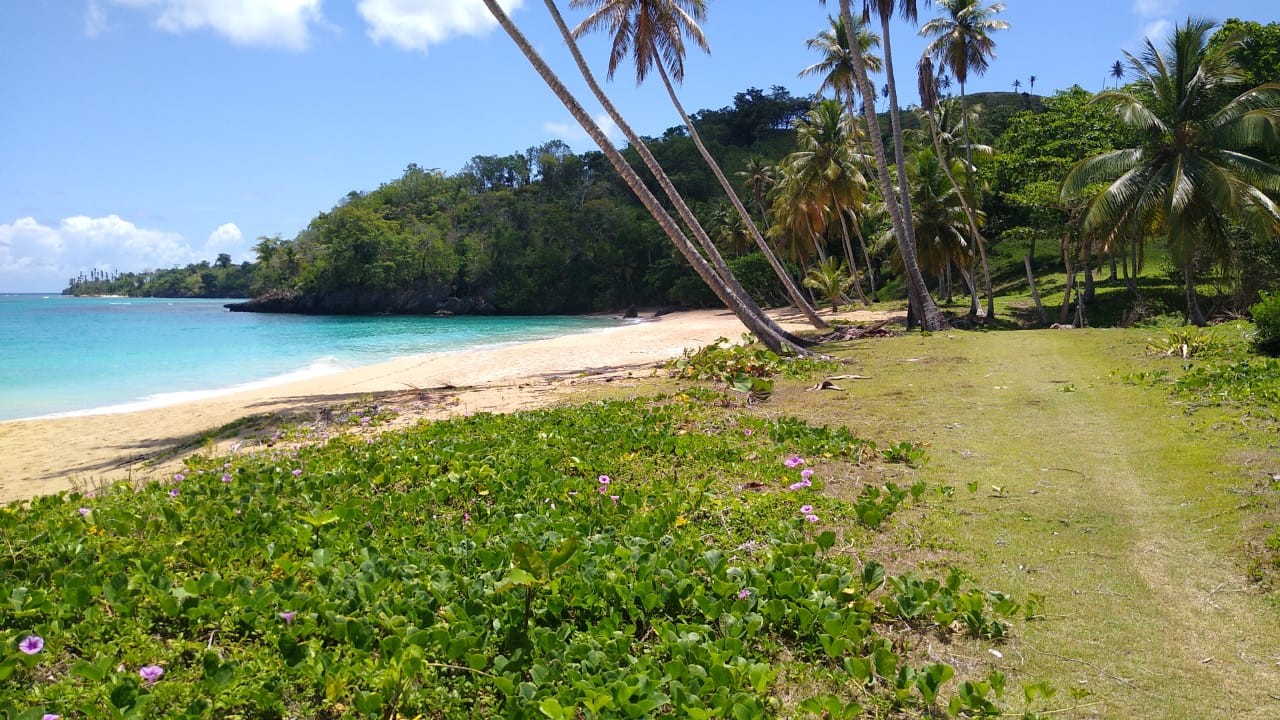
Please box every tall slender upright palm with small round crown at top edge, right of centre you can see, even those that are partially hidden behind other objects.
[920,0,1021,322]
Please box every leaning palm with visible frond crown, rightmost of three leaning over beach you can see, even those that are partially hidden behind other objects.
[565,0,829,329]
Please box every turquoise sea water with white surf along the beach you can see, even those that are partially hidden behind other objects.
[0,295,617,420]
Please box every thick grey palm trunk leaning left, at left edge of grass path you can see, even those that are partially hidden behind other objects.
[840,0,947,331]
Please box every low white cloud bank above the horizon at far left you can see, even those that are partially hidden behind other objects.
[0,214,248,292]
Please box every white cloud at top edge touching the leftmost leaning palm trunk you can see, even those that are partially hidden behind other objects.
[356,0,524,53]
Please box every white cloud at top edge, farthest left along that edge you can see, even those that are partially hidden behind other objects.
[108,0,325,50]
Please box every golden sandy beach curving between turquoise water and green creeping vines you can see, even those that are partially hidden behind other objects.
[0,304,839,503]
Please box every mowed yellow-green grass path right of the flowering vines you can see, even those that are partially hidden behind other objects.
[768,331,1280,719]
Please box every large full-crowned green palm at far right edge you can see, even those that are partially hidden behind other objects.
[1062,18,1280,325]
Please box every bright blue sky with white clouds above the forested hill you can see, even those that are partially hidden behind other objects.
[0,0,1280,292]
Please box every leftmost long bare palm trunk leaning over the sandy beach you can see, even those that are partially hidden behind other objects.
[484,0,804,352]
